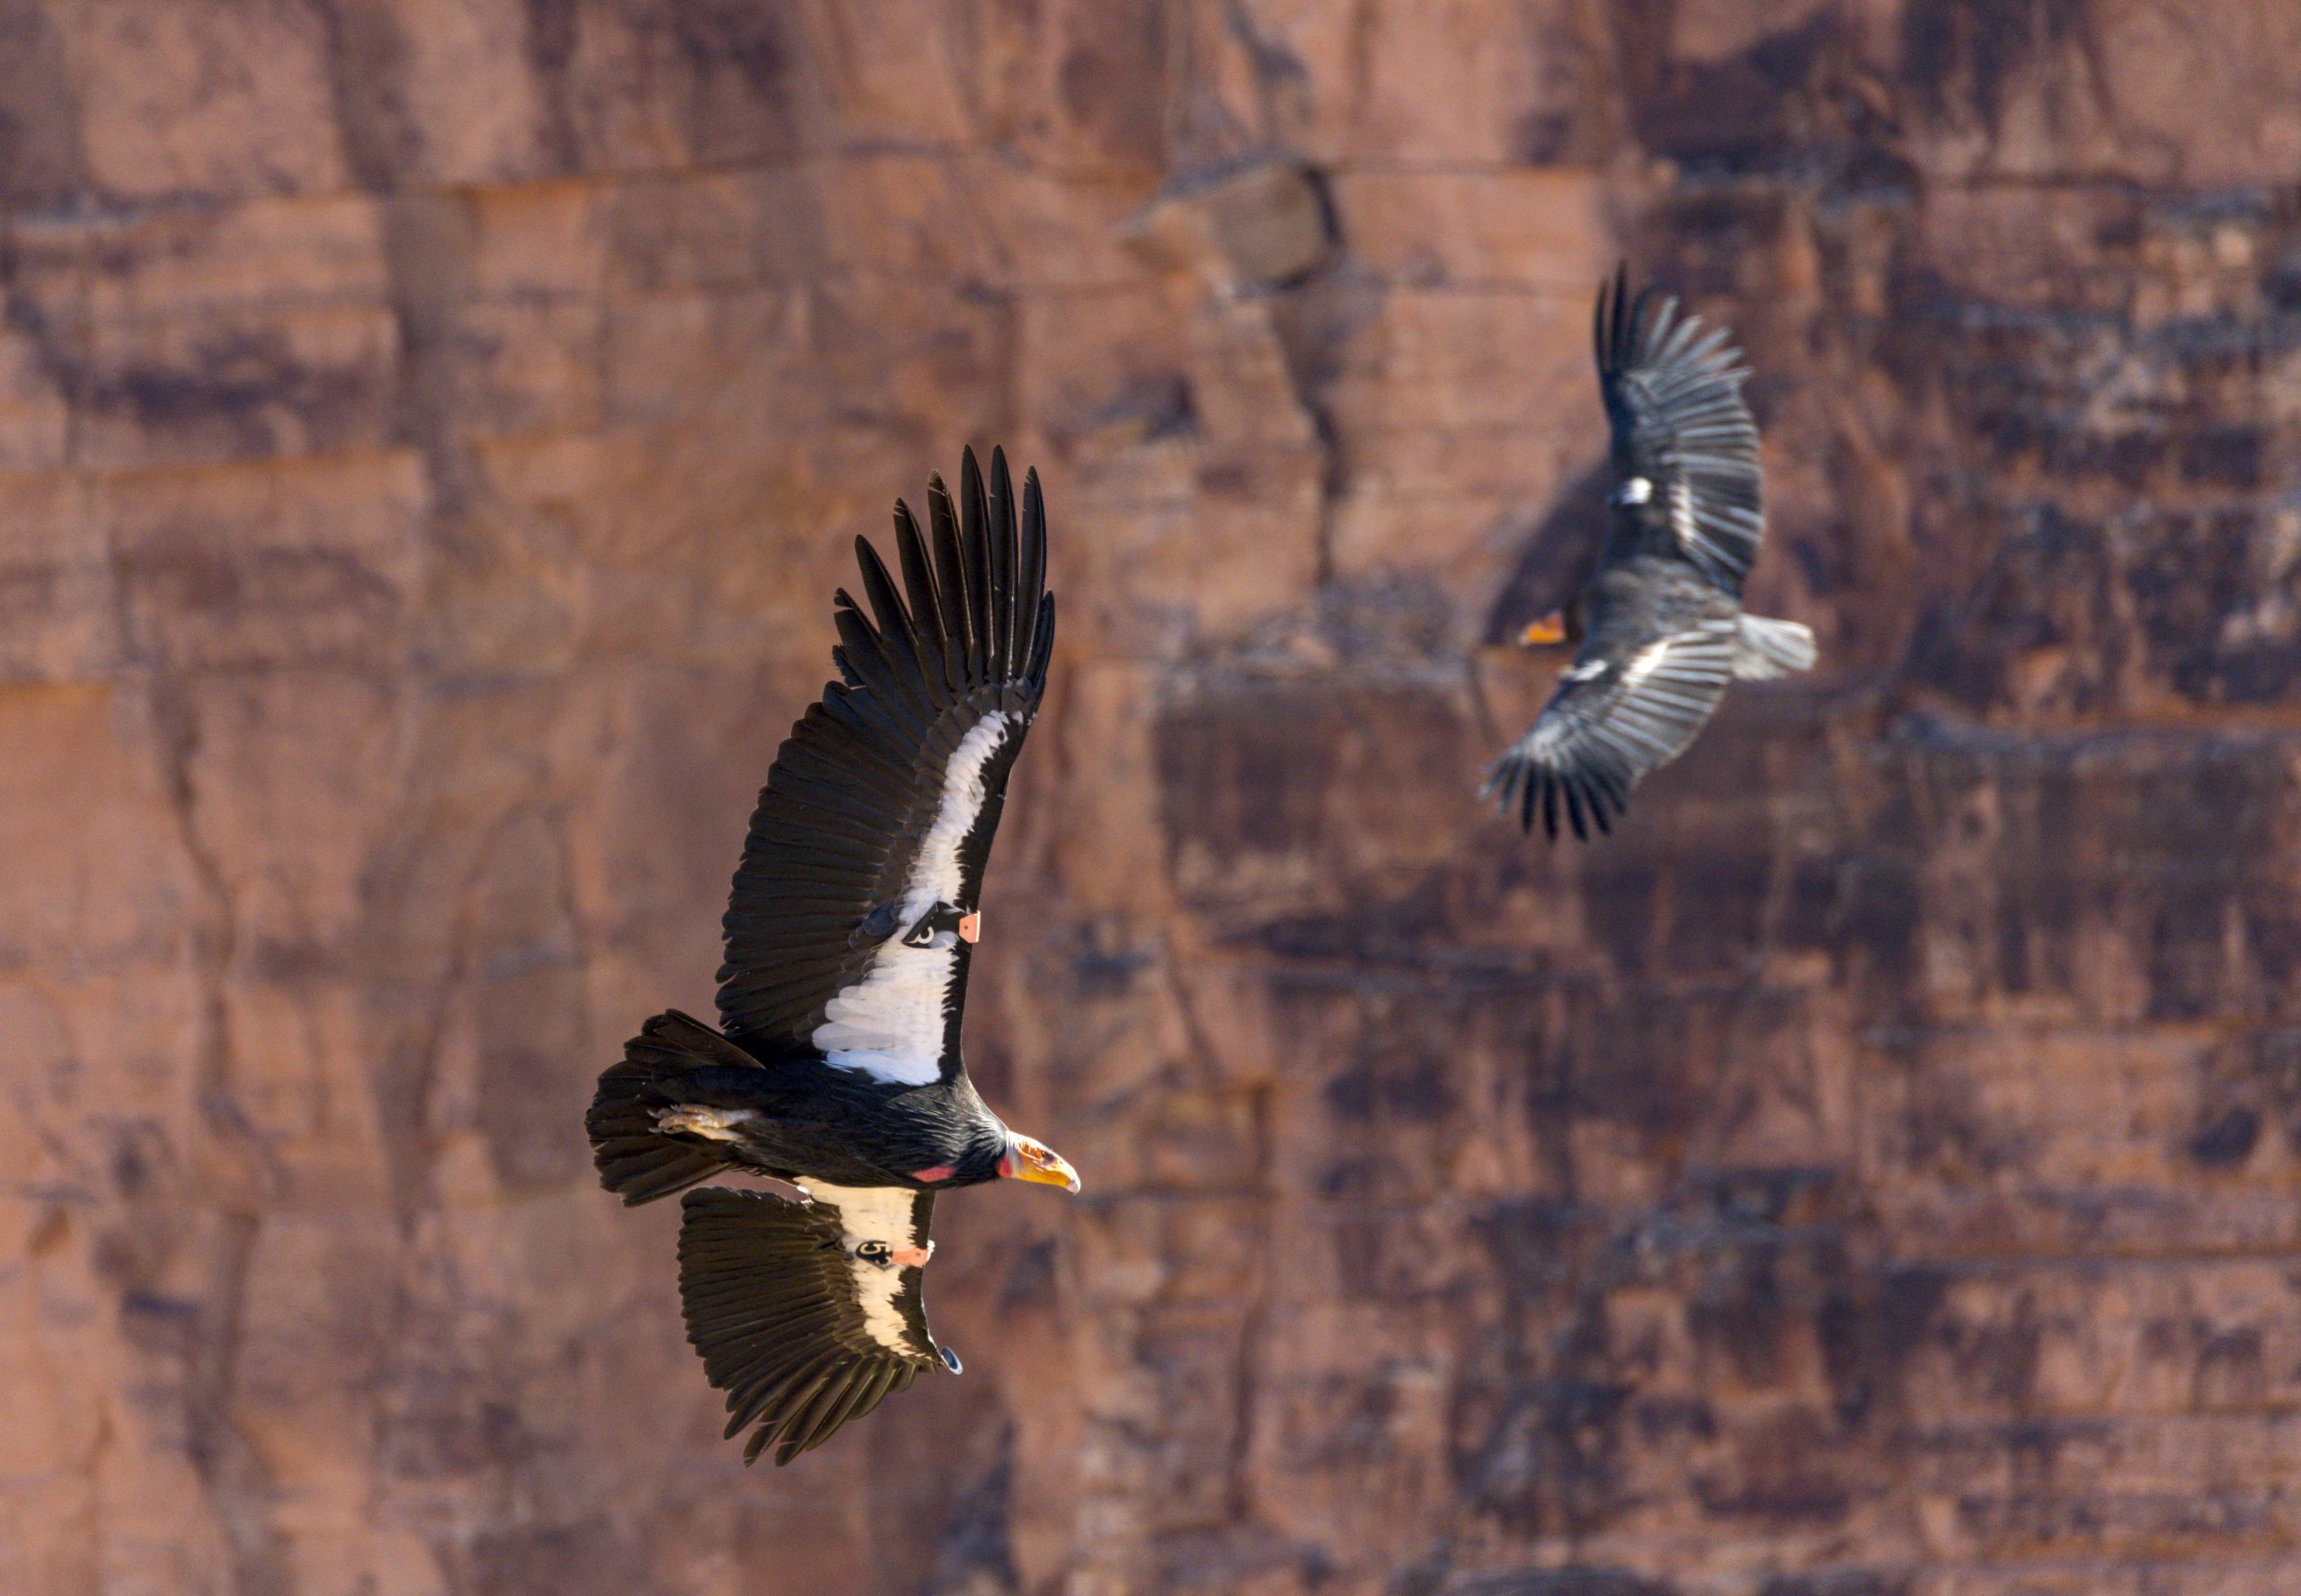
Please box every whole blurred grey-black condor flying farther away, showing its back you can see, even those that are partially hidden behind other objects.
[1487,271,1813,839]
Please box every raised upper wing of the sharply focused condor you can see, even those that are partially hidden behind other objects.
[718,451,1053,1086]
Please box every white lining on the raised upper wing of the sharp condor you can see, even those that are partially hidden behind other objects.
[810,711,1017,1086]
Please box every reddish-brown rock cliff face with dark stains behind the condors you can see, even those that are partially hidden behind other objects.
[0,0,2301,1596]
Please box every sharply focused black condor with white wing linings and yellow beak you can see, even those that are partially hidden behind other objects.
[587,451,1079,1463]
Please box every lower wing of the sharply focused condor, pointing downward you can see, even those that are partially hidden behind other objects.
[679,1182,960,1465]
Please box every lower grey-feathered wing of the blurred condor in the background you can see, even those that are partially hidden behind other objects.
[1487,618,1735,839]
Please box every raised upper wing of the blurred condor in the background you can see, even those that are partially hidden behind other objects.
[1595,267,1765,596]
